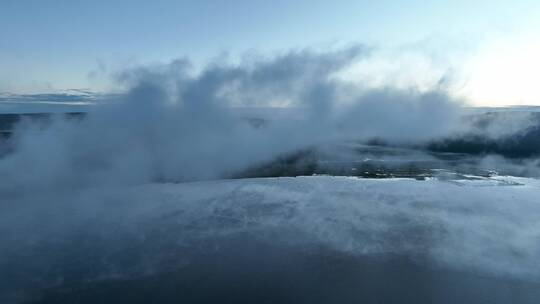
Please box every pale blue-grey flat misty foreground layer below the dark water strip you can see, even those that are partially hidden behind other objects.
[0,176,540,303]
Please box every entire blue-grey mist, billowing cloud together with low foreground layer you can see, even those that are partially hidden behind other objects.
[0,45,539,303]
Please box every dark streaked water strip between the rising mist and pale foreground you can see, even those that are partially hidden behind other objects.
[237,145,505,180]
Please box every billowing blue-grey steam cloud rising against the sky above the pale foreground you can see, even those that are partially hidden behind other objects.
[0,46,459,193]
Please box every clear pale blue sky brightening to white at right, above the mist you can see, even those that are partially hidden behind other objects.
[0,0,540,105]
